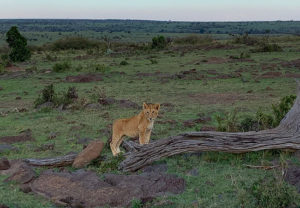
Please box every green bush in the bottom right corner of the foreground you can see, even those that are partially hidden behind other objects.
[251,177,299,208]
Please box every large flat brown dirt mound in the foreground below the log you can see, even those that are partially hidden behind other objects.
[31,170,185,207]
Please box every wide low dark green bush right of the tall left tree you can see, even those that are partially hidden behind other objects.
[50,37,104,50]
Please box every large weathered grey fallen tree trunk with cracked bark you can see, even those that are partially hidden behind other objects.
[119,82,300,171]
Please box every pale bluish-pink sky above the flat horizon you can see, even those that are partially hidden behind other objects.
[0,0,300,21]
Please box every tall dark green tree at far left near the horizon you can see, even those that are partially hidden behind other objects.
[6,26,31,62]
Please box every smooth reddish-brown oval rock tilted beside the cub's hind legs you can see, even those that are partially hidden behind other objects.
[72,140,104,168]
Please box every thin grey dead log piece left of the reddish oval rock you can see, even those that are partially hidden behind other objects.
[24,153,78,167]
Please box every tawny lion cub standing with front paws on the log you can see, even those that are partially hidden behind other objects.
[110,103,160,156]
